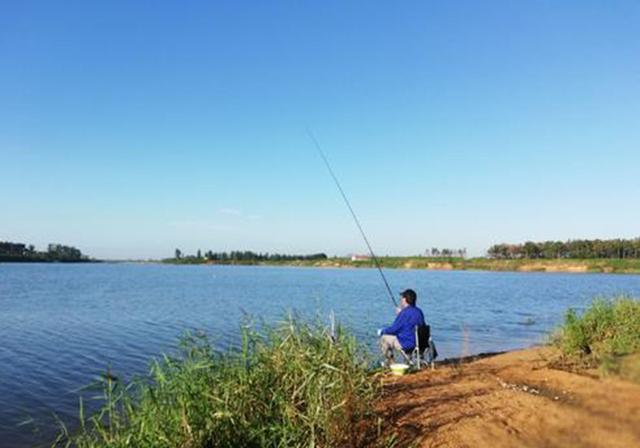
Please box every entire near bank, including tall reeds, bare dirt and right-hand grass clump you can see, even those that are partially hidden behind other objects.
[47,296,640,448]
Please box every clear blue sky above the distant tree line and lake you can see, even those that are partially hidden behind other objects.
[0,0,640,258]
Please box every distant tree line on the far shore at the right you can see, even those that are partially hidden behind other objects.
[487,238,640,259]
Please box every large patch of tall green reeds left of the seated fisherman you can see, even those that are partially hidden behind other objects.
[54,319,379,448]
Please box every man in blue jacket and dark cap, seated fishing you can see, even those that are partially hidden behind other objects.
[378,289,424,365]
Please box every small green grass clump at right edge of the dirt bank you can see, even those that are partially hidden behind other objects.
[553,296,640,373]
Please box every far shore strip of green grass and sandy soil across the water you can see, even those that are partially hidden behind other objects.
[186,257,640,274]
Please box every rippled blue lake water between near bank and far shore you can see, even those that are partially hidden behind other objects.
[0,264,640,447]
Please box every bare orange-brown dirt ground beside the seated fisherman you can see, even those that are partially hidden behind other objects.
[380,348,640,448]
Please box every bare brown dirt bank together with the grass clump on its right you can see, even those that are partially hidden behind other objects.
[376,297,640,448]
